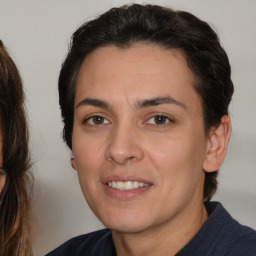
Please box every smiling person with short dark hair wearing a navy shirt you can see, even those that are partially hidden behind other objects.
[49,4,256,256]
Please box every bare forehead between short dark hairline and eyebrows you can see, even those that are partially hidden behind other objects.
[75,43,199,111]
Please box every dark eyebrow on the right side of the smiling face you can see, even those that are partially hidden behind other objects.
[136,96,187,109]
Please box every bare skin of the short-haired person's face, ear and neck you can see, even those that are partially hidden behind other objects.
[71,44,230,255]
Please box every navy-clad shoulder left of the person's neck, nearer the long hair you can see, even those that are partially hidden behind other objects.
[46,229,112,256]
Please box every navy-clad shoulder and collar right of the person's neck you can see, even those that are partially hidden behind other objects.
[177,202,256,256]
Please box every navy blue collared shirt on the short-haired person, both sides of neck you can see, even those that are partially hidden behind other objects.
[46,202,256,256]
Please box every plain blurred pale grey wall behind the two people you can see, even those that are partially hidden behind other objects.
[0,0,256,256]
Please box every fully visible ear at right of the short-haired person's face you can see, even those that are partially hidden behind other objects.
[203,115,231,172]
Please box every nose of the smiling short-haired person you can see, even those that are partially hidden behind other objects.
[106,125,144,165]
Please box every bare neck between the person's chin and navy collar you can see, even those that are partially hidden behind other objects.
[112,203,207,256]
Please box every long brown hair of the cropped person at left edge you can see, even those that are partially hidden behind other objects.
[0,40,33,256]
